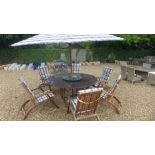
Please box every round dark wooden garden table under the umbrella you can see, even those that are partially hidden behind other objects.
[48,73,97,98]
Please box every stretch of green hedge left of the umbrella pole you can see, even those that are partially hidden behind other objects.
[0,48,69,64]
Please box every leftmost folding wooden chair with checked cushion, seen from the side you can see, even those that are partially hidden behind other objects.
[19,78,59,120]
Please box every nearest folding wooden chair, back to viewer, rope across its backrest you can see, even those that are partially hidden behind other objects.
[68,88,103,120]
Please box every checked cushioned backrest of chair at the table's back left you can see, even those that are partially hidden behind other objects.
[39,66,52,84]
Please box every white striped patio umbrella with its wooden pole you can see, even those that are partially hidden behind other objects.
[11,34,124,71]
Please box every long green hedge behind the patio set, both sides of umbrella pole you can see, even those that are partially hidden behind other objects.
[0,45,155,64]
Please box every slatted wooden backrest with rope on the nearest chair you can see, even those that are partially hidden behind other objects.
[75,88,103,115]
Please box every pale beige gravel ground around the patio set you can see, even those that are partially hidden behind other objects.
[0,64,155,121]
